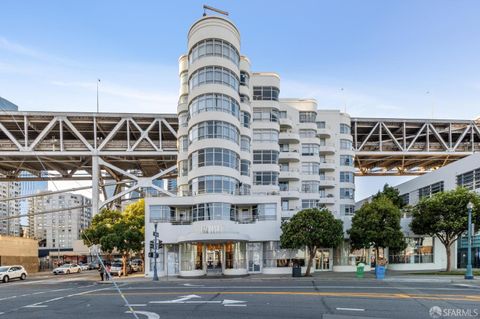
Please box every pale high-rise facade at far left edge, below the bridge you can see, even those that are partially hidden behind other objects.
[0,182,21,237]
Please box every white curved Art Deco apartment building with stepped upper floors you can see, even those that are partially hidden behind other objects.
[146,16,354,277]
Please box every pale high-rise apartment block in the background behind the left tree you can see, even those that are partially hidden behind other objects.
[28,192,92,248]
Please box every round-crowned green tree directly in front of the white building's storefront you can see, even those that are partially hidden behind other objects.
[280,208,343,276]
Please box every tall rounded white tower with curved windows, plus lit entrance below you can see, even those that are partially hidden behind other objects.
[177,16,252,276]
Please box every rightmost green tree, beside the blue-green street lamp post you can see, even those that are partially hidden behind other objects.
[410,187,480,271]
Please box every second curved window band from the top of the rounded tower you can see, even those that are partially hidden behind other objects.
[189,66,239,91]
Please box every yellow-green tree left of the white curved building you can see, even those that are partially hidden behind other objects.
[82,199,145,274]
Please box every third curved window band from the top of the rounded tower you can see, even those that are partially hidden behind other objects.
[188,93,240,119]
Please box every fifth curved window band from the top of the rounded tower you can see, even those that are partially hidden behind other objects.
[188,148,240,170]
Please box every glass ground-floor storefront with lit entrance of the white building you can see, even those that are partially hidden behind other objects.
[146,241,340,277]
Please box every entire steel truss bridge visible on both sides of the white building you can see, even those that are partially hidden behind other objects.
[0,112,480,211]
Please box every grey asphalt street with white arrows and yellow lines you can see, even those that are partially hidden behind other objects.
[0,271,480,319]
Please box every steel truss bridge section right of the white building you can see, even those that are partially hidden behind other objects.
[352,118,480,176]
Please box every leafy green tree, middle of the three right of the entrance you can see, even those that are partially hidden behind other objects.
[347,195,407,261]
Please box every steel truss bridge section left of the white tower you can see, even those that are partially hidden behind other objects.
[0,112,178,211]
